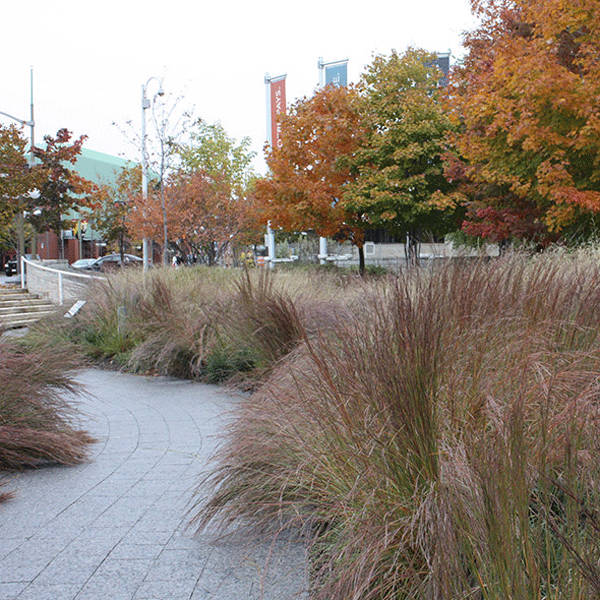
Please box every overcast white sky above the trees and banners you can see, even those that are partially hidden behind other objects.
[0,0,474,170]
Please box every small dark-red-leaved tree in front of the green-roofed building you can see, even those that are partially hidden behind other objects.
[28,129,94,257]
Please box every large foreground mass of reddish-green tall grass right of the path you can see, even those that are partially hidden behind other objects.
[194,254,600,600]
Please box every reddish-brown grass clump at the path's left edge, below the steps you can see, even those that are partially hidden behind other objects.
[0,340,93,502]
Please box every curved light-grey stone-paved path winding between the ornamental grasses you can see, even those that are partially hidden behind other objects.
[0,370,307,600]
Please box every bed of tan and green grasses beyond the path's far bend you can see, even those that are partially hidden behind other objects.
[47,268,354,385]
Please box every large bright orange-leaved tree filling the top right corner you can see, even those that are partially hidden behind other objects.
[448,0,600,244]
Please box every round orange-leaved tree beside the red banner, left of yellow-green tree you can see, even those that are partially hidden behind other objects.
[256,86,364,272]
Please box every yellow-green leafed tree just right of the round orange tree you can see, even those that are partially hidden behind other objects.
[343,49,456,261]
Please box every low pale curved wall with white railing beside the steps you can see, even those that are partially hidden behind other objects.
[21,256,104,304]
